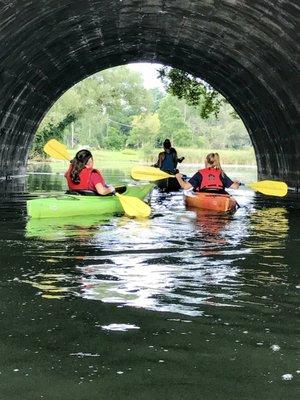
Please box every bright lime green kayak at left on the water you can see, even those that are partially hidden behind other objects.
[27,184,153,218]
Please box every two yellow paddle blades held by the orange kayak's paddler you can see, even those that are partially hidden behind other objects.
[131,166,288,197]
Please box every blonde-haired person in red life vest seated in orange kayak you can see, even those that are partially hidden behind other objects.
[176,153,240,194]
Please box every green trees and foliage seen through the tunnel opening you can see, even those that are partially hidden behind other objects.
[31,66,251,158]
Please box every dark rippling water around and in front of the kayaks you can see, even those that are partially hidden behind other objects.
[0,164,300,400]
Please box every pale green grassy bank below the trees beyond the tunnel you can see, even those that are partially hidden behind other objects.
[29,148,256,172]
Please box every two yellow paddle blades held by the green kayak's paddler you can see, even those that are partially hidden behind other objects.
[44,139,151,218]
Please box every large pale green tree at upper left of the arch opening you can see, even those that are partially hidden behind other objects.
[31,67,153,153]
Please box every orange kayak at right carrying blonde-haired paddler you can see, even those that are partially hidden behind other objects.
[184,192,237,212]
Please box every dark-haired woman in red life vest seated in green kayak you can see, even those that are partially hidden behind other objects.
[65,150,115,196]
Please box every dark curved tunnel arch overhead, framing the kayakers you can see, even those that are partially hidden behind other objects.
[0,0,300,188]
